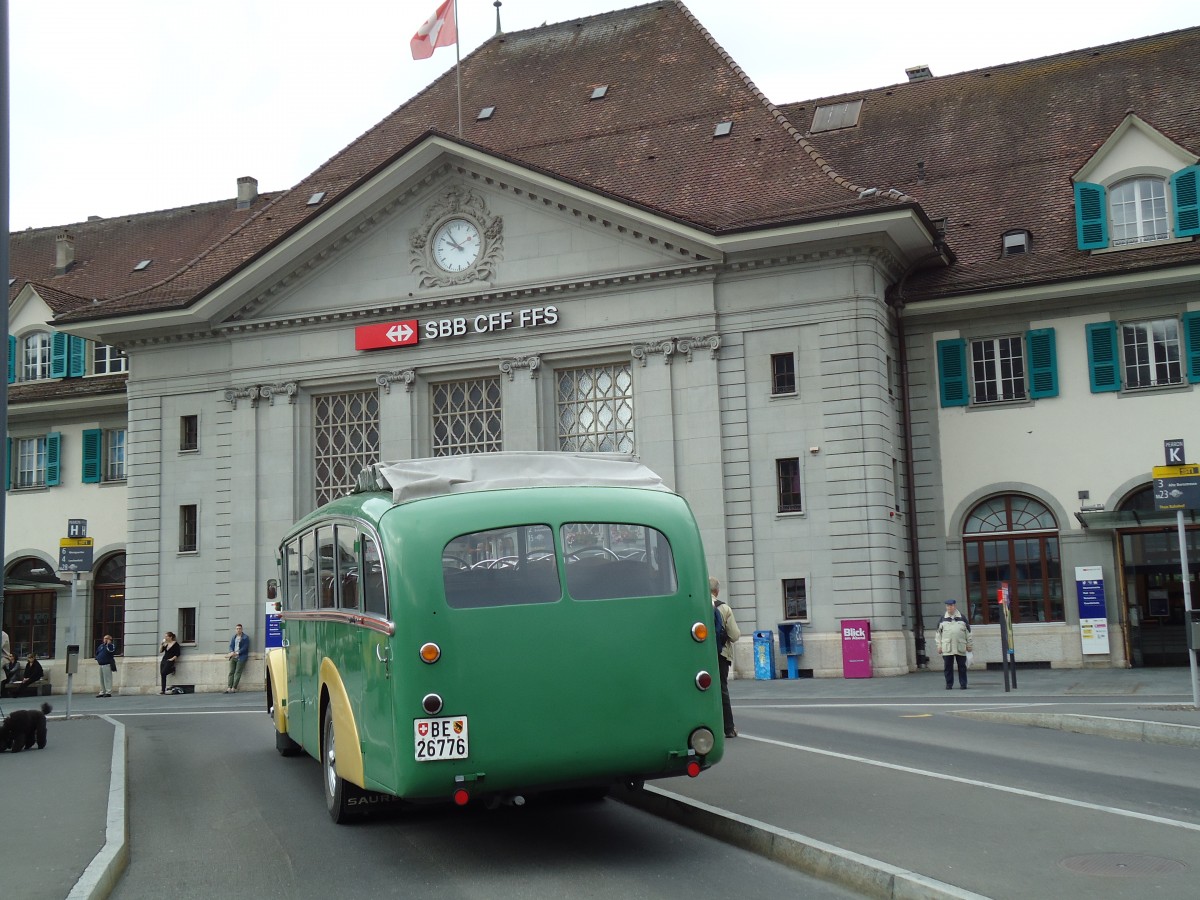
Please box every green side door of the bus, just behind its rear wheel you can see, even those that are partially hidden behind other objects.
[358,534,398,790]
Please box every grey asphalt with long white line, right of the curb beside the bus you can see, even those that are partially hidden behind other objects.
[662,692,1200,900]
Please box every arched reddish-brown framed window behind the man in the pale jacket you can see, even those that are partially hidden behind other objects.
[962,494,1066,624]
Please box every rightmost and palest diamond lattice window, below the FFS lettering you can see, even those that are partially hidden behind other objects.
[558,365,634,454]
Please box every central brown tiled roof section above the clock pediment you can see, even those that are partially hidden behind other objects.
[46,2,893,320]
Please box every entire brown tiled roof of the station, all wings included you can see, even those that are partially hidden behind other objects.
[10,2,1200,324]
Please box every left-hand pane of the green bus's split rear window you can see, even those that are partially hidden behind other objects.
[442,524,563,610]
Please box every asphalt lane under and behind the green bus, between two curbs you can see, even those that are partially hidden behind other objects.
[109,695,857,900]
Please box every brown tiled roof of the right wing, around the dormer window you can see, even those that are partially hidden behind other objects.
[784,28,1200,300]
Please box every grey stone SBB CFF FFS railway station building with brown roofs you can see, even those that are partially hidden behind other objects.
[4,2,1200,691]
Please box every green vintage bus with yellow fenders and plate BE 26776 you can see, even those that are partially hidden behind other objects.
[266,452,724,822]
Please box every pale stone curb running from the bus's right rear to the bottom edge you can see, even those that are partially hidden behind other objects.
[610,785,988,900]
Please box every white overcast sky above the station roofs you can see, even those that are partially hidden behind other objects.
[8,0,1200,230]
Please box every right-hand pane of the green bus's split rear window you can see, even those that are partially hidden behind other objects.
[563,522,677,600]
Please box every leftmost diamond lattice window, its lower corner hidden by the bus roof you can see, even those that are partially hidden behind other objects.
[313,391,379,506]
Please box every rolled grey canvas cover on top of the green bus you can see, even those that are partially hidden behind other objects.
[358,451,671,504]
